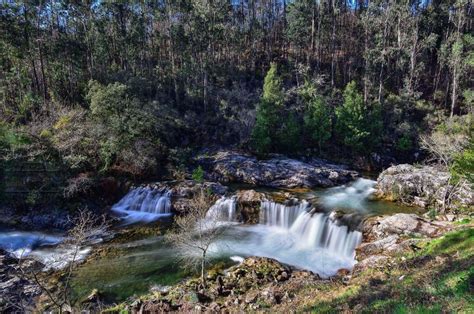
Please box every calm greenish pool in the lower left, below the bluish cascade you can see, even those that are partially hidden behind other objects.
[72,237,189,302]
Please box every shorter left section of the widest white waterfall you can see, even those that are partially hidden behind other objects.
[260,201,309,229]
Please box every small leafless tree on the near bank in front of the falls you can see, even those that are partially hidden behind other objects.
[166,189,225,288]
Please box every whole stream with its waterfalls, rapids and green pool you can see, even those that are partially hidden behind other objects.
[0,179,418,302]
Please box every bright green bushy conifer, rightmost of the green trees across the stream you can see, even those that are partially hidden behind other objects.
[336,81,382,153]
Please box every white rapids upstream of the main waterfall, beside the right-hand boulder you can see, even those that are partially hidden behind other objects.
[321,178,376,212]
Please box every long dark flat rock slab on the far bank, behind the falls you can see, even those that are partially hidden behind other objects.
[198,151,358,188]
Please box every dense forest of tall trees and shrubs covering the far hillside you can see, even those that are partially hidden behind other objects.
[0,0,473,180]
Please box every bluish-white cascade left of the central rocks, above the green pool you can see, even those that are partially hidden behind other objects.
[112,187,172,224]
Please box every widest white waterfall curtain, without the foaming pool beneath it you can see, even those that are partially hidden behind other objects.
[260,201,362,259]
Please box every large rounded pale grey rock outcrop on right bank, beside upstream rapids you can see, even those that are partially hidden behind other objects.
[376,164,474,208]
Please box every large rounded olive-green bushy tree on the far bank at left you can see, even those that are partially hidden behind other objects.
[87,81,160,174]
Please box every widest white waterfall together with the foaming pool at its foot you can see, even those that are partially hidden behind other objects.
[207,201,362,277]
